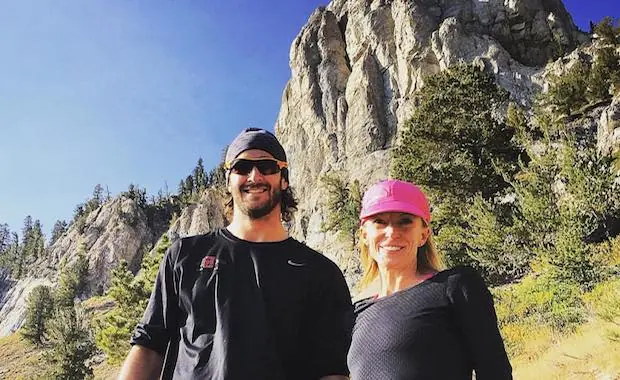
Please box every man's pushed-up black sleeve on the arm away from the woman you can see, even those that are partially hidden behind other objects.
[130,240,181,356]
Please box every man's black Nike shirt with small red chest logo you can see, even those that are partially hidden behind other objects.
[132,229,353,380]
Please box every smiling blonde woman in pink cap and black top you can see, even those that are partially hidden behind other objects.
[348,180,512,380]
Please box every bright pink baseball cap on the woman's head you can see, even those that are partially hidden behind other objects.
[360,179,431,224]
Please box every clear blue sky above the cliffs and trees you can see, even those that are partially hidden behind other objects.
[0,0,620,236]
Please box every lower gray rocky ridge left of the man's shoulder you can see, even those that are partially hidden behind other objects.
[0,196,164,336]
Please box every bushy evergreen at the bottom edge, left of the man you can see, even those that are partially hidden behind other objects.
[44,307,96,380]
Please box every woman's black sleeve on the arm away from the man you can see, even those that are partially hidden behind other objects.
[448,267,512,380]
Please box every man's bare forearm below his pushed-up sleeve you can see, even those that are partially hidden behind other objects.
[118,345,164,380]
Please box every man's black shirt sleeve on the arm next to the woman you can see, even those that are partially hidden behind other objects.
[306,262,355,378]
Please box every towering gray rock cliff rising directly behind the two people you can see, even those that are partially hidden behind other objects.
[275,0,585,274]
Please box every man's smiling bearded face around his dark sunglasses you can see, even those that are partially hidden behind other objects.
[228,149,288,219]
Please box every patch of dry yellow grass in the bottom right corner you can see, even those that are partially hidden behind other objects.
[512,320,620,380]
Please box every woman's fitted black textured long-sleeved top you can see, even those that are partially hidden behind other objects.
[349,267,512,380]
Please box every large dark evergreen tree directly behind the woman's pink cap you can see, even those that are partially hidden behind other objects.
[391,65,526,281]
